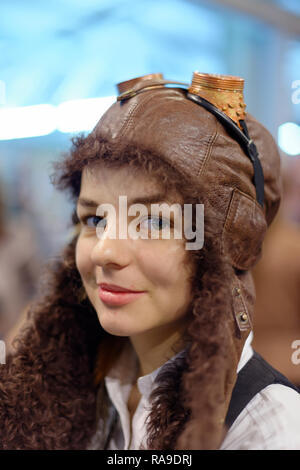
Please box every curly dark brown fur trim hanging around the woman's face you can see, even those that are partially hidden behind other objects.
[0,133,239,450]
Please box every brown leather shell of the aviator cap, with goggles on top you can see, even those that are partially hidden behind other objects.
[93,73,281,447]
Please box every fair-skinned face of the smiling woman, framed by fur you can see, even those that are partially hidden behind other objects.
[76,163,195,337]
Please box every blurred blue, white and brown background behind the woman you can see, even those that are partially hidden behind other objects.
[0,0,300,384]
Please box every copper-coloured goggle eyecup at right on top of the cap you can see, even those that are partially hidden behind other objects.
[188,72,246,129]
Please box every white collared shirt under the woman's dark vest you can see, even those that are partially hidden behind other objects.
[90,332,300,450]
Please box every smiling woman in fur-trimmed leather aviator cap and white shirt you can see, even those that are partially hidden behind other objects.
[0,74,300,450]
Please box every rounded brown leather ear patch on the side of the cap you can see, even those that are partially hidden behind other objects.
[222,188,267,270]
